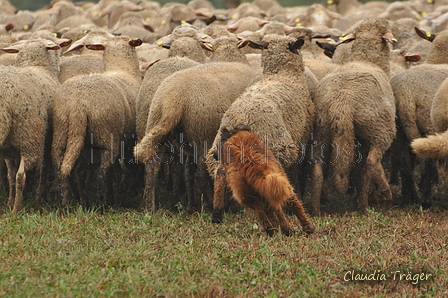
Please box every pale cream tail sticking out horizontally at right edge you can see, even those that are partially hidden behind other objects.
[411,130,448,158]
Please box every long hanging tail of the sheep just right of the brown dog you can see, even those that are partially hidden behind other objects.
[330,110,355,195]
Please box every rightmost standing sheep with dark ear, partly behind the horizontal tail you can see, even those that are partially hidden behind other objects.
[391,28,448,205]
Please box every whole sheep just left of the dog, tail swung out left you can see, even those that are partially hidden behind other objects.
[134,39,259,210]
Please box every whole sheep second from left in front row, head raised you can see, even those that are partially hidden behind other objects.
[51,37,142,207]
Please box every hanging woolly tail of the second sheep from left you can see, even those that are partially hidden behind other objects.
[61,108,87,178]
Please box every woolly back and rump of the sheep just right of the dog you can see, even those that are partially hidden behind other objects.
[314,62,395,150]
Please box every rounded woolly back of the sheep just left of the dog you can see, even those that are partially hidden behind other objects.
[147,62,260,145]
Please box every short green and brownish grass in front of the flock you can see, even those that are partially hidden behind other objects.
[0,208,448,297]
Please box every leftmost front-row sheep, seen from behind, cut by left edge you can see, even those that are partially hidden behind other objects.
[0,39,65,213]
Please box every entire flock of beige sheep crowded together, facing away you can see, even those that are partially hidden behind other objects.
[0,0,448,222]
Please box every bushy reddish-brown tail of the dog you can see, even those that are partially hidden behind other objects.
[253,173,294,209]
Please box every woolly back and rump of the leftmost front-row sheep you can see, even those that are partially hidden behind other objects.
[0,67,57,167]
